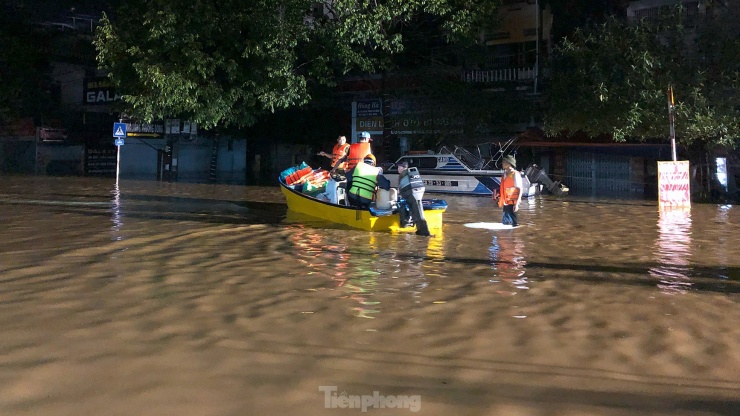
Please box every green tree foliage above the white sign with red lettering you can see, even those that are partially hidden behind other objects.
[545,2,740,147]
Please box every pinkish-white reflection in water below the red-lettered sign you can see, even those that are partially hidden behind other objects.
[650,209,692,294]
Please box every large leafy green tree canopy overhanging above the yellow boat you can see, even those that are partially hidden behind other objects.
[95,0,497,128]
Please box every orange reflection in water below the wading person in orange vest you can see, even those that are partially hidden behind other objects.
[488,234,529,295]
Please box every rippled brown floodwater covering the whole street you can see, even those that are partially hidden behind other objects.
[0,176,740,416]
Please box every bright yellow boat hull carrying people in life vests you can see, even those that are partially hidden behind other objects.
[279,178,447,233]
